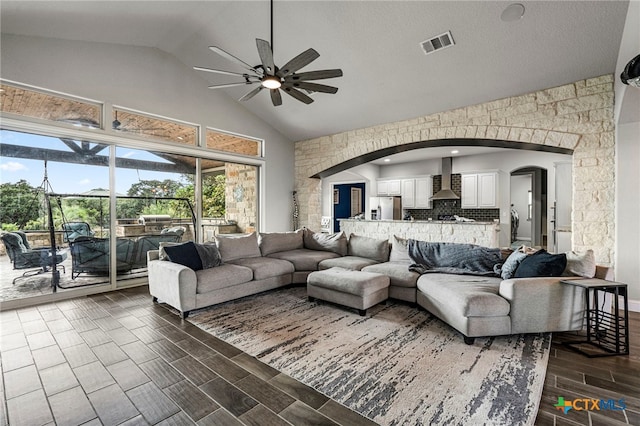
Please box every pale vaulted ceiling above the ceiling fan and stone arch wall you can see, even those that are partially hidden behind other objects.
[0,0,628,141]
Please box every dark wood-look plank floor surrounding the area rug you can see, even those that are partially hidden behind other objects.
[0,287,640,426]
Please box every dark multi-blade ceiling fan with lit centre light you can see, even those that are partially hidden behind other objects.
[193,0,342,106]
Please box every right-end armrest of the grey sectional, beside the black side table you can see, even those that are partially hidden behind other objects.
[500,277,585,333]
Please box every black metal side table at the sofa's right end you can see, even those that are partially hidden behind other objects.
[560,278,629,358]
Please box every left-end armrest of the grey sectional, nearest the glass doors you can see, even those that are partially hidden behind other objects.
[148,260,198,312]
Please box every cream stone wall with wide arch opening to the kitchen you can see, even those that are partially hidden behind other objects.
[295,75,615,266]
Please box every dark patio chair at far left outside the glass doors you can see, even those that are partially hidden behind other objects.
[0,231,67,285]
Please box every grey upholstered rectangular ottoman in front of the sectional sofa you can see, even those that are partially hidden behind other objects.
[307,267,389,316]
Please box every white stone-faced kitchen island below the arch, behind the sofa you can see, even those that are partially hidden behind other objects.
[339,219,500,247]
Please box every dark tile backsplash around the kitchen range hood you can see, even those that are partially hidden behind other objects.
[405,174,500,222]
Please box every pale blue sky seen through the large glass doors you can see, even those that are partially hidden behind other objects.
[0,130,181,194]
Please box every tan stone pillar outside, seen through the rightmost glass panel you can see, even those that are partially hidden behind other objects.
[225,163,258,232]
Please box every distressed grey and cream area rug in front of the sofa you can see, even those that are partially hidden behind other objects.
[189,287,551,425]
